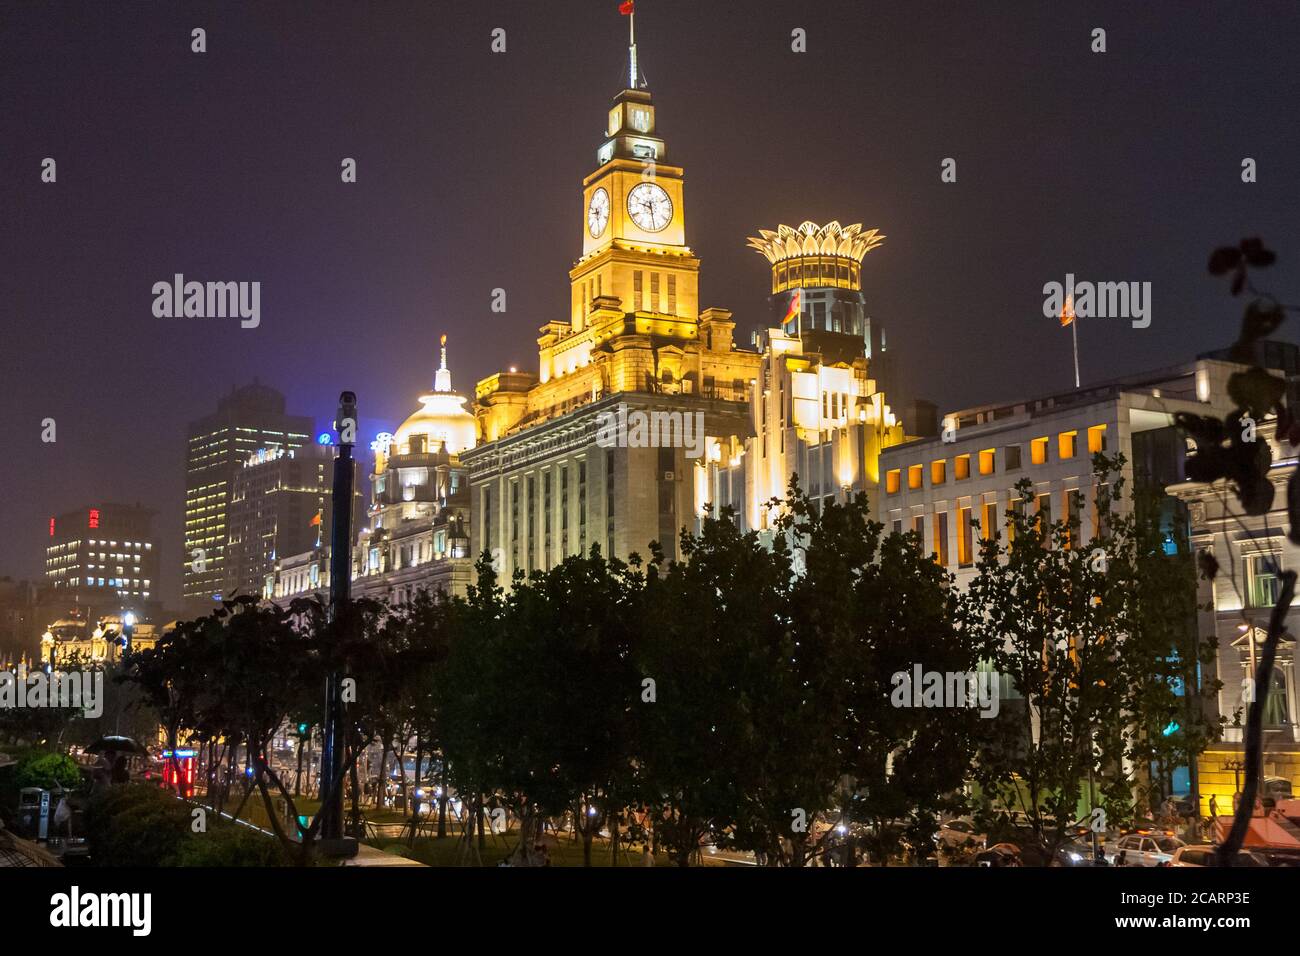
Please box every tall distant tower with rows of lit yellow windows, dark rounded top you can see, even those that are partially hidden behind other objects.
[181,384,312,614]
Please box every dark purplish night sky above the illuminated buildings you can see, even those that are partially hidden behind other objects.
[0,0,1300,606]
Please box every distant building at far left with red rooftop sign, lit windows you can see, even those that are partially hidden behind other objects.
[46,502,161,618]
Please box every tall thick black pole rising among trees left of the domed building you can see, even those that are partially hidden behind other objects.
[320,392,356,856]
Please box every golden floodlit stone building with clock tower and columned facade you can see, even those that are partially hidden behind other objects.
[462,29,759,580]
